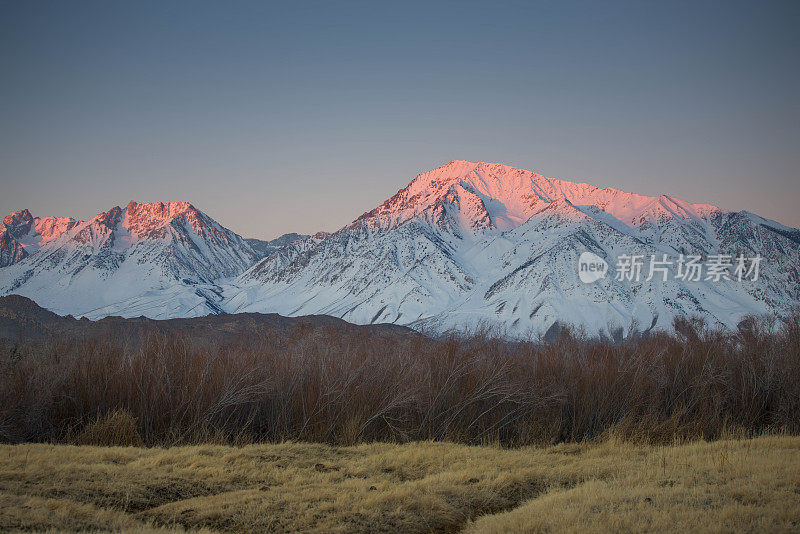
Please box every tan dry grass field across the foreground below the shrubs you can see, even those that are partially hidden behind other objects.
[0,436,800,532]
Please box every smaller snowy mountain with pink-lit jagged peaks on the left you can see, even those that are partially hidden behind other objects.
[0,202,259,318]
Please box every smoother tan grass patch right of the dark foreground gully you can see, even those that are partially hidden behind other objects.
[465,438,800,533]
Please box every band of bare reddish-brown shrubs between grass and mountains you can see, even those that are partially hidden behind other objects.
[0,315,800,446]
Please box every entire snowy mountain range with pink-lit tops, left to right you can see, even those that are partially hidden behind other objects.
[0,161,800,336]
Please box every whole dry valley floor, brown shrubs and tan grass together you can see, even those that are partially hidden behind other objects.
[0,315,800,532]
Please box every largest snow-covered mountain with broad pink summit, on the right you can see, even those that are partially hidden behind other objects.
[223,161,800,335]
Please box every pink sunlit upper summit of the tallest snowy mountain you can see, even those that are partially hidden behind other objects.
[357,160,720,231]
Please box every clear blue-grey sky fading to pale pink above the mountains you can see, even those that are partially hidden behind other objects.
[0,0,800,238]
